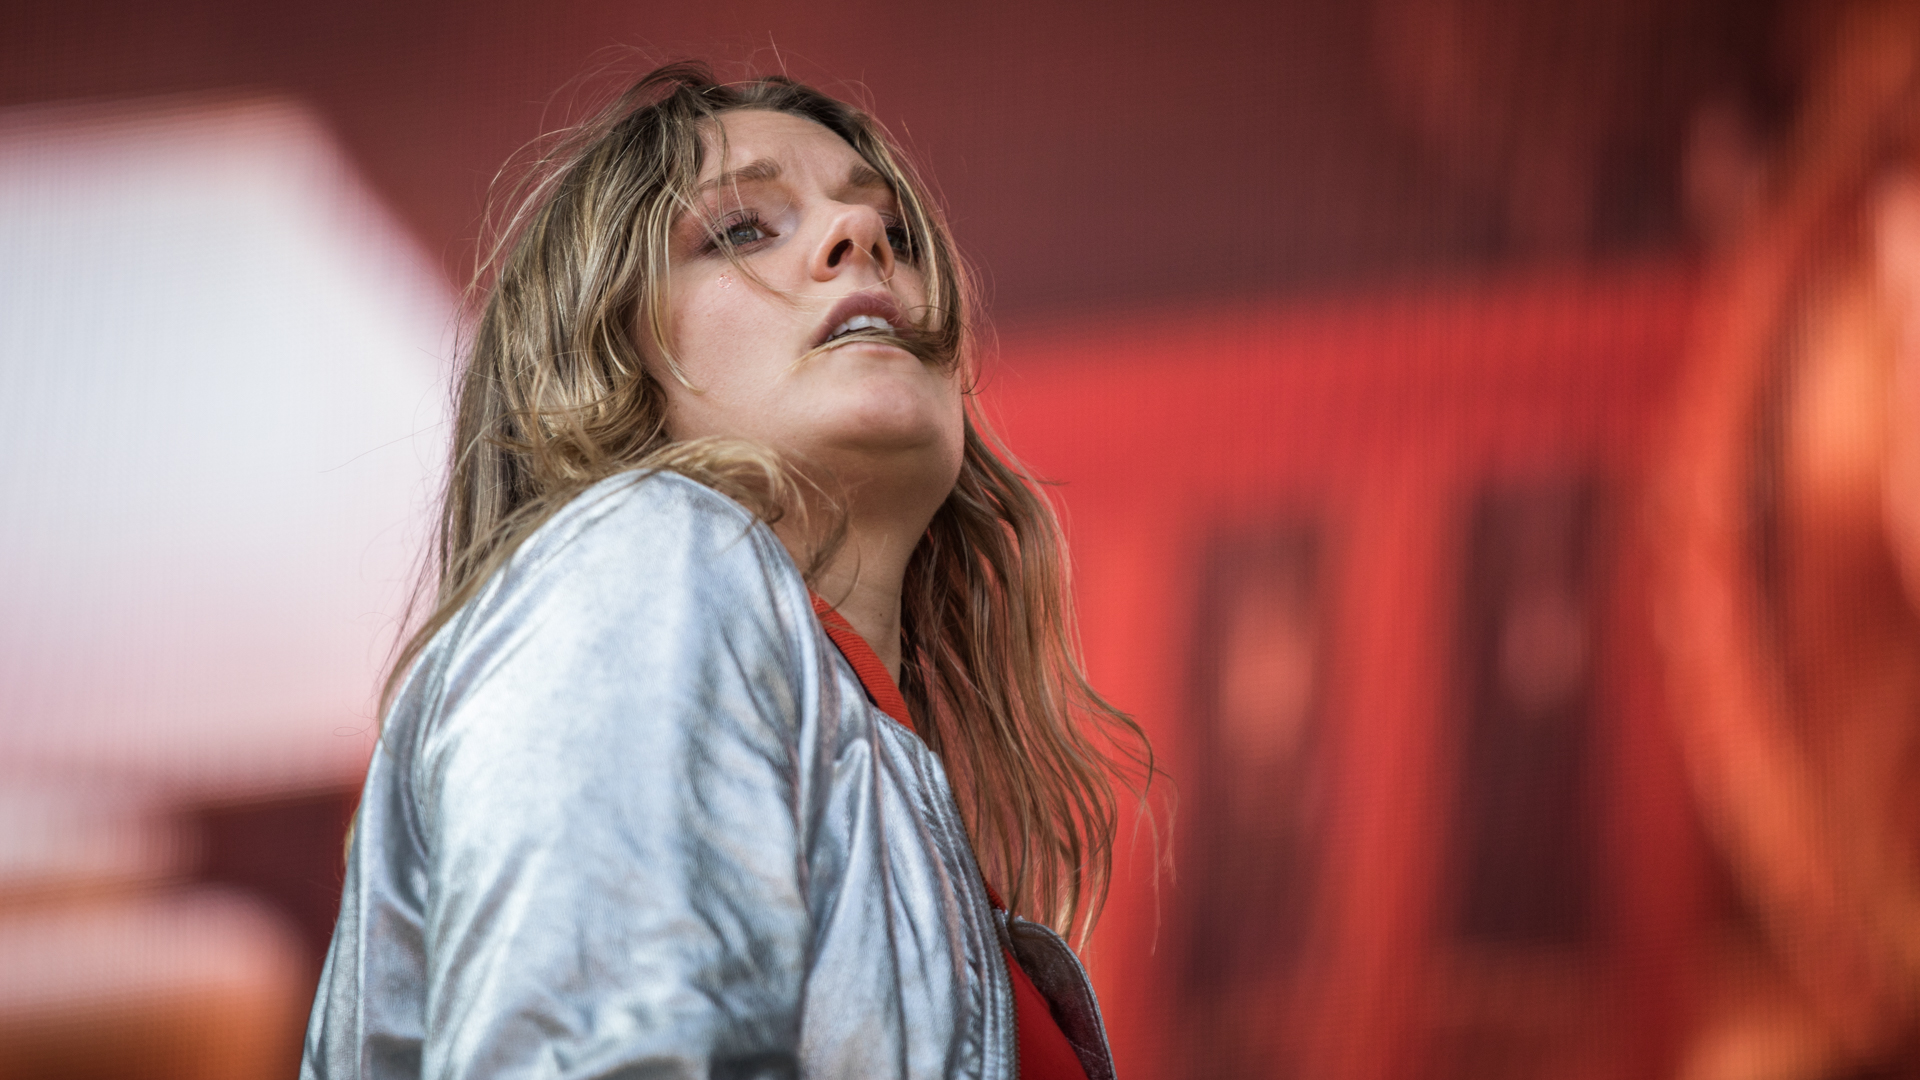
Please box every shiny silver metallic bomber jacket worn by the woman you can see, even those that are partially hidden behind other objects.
[301,473,1112,1080]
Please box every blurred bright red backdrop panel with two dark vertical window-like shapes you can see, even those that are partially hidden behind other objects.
[983,265,1699,1080]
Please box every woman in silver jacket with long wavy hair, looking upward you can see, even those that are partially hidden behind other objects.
[291,65,1150,1080]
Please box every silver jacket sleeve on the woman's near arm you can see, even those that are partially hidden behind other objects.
[412,477,818,1078]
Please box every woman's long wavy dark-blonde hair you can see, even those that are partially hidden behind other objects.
[386,63,1154,940]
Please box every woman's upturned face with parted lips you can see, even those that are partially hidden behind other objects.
[639,110,962,505]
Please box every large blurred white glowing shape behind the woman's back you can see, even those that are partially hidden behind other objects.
[0,100,453,788]
